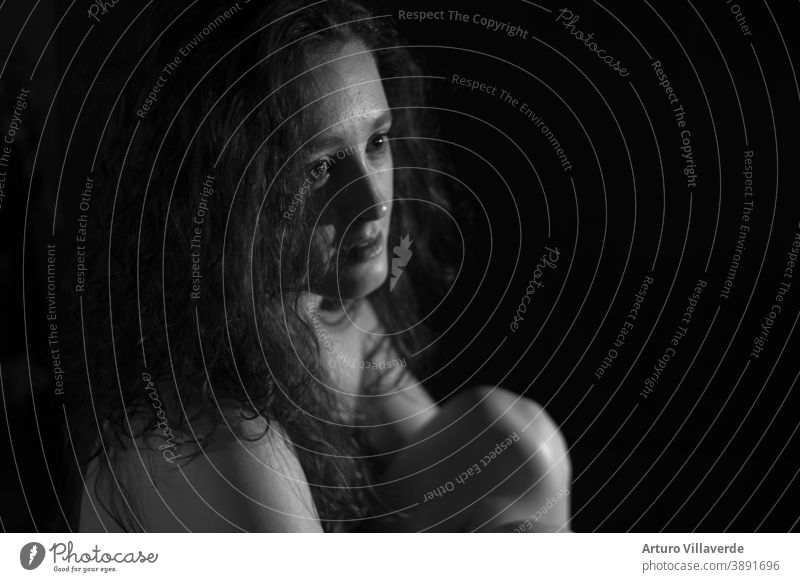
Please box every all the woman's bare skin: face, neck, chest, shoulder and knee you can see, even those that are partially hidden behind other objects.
[80,43,570,532]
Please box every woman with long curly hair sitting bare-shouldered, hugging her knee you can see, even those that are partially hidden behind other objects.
[69,0,569,531]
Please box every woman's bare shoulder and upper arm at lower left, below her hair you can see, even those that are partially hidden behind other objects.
[80,417,322,532]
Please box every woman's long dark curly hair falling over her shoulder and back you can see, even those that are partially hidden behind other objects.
[67,0,452,531]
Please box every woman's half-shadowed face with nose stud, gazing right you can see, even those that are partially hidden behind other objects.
[304,42,393,300]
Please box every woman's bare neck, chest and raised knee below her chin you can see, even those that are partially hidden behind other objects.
[310,303,571,532]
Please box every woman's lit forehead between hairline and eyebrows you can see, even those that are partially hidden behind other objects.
[307,42,389,131]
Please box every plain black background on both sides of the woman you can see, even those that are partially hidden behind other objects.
[0,1,800,531]
